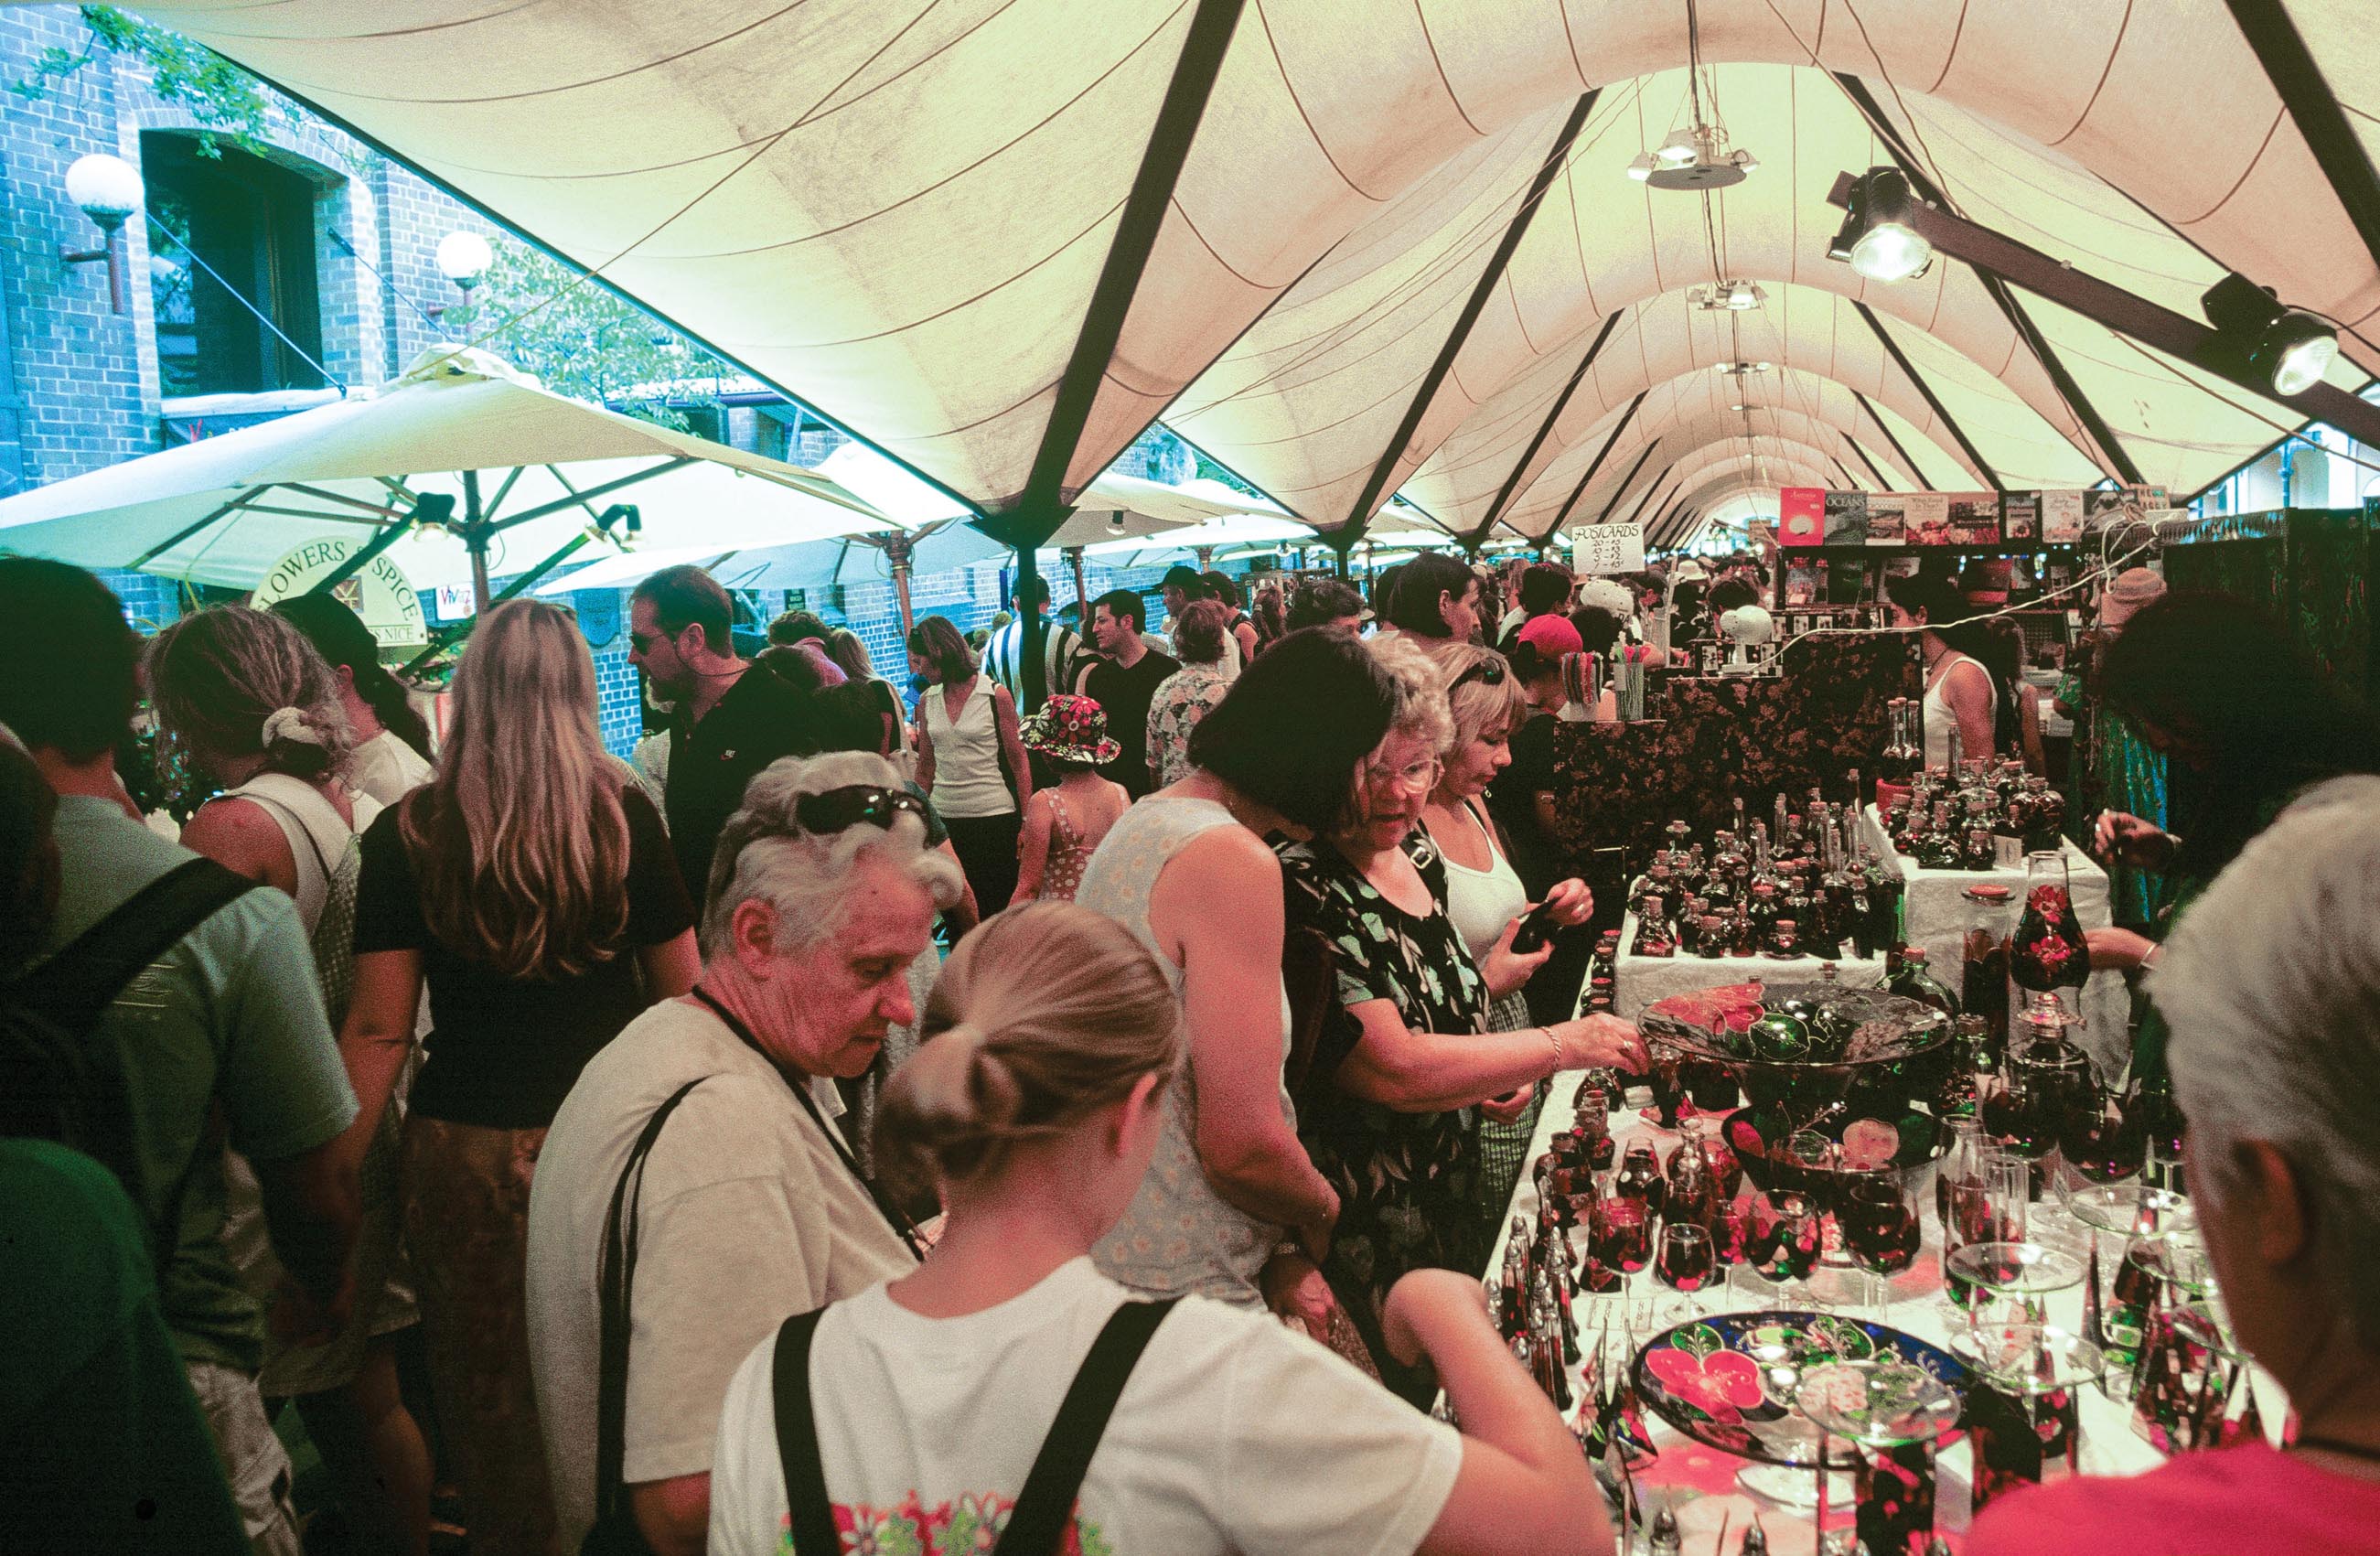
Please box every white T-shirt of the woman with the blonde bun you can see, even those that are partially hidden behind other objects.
[709,1259,1463,1556]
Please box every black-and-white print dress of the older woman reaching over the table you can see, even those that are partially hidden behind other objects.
[1281,832,1487,1404]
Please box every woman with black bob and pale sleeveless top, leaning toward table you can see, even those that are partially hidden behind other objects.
[1076,628,1397,1309]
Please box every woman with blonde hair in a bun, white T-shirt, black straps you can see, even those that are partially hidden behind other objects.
[709,902,1612,1556]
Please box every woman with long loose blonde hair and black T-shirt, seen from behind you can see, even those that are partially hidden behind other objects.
[338,599,700,1556]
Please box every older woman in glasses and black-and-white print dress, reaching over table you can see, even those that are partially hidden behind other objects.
[1282,640,1645,1401]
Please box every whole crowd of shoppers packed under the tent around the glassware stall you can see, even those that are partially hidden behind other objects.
[0,542,2380,1556]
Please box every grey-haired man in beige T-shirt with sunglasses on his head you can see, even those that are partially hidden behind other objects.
[529,752,961,1556]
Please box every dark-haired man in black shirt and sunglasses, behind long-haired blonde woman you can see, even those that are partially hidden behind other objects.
[628,566,814,907]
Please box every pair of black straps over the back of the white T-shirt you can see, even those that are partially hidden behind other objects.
[771,1299,1178,1556]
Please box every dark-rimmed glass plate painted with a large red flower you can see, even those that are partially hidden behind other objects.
[1635,1314,1968,1468]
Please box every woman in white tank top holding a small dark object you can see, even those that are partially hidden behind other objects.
[1420,642,1594,1230]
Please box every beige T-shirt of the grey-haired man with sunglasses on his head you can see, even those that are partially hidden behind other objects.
[529,999,917,1551]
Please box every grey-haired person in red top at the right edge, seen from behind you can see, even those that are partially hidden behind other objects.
[1968,776,2380,1556]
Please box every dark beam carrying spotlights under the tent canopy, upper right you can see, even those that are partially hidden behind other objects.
[1828,174,2380,456]
